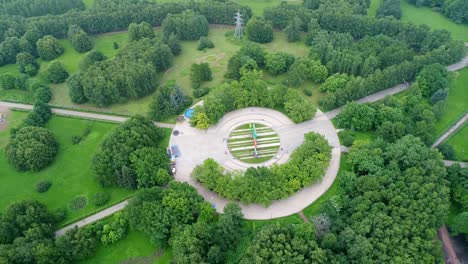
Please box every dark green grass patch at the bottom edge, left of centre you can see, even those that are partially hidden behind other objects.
[80,231,172,264]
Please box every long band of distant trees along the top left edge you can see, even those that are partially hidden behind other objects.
[0,1,252,41]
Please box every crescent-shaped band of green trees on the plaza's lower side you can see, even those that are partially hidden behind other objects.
[192,133,331,206]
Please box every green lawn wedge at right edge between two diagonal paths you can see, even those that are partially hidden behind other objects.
[436,68,468,136]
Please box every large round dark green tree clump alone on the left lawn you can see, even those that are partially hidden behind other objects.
[5,126,58,171]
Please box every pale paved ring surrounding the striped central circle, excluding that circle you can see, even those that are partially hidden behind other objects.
[170,107,341,219]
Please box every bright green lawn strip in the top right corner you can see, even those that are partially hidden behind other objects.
[398,0,468,42]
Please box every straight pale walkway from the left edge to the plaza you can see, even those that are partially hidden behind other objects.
[0,101,175,128]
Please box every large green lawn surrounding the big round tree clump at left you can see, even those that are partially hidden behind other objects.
[0,111,132,224]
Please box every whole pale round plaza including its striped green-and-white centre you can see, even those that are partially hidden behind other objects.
[170,107,341,220]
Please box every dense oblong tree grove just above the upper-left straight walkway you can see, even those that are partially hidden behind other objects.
[67,38,174,107]
